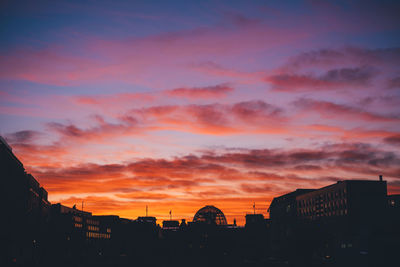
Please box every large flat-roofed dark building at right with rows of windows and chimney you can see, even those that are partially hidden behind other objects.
[270,179,387,265]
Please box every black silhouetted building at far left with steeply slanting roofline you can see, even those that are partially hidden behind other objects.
[0,137,50,264]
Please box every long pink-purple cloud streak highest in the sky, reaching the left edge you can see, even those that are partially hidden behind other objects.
[0,20,305,87]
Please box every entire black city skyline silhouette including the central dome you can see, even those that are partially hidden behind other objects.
[0,138,400,267]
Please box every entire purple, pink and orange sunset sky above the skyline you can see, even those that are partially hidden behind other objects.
[0,1,400,224]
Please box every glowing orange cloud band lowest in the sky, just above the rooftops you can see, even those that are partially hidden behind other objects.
[21,143,400,226]
